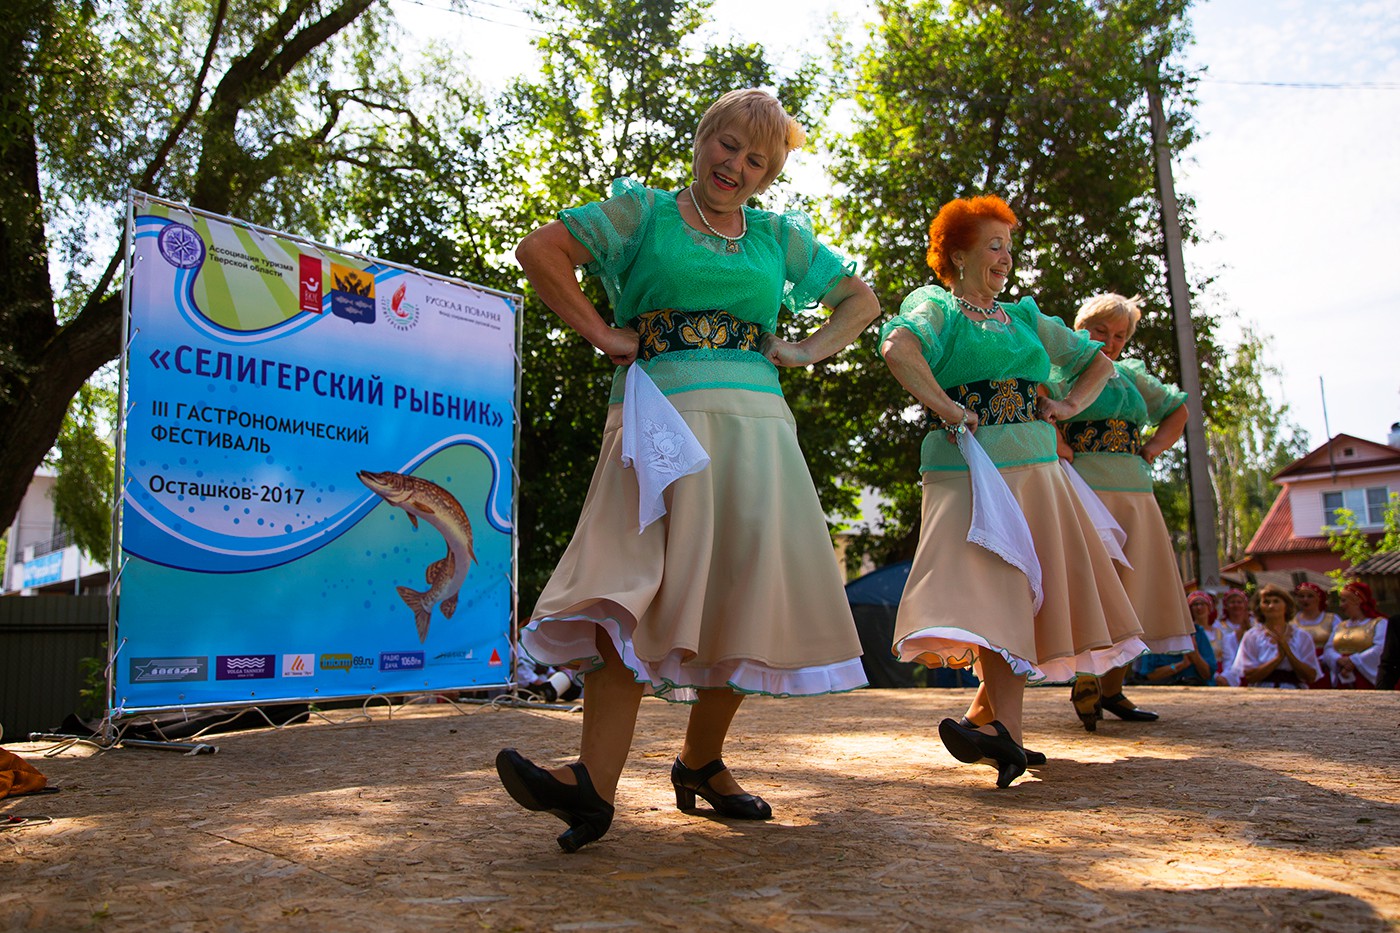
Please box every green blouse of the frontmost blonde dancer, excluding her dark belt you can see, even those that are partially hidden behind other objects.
[559,178,855,402]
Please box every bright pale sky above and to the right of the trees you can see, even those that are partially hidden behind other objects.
[392,0,1400,447]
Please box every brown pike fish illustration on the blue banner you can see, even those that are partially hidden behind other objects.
[356,469,476,643]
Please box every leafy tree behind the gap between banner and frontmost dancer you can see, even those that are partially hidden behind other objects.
[338,0,809,609]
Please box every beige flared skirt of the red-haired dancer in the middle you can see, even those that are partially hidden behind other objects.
[895,464,1147,682]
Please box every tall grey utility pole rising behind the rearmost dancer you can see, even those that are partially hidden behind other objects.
[1147,72,1221,590]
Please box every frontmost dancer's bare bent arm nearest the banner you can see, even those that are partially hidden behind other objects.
[515,220,638,366]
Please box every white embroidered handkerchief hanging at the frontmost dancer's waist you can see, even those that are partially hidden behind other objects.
[622,363,710,535]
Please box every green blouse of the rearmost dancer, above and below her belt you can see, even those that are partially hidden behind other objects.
[1056,360,1186,492]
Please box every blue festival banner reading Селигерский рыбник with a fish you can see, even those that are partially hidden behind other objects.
[113,193,521,712]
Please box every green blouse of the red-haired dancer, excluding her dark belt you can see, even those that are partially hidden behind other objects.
[881,286,1103,472]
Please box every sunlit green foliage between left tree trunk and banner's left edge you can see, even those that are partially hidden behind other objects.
[50,381,116,563]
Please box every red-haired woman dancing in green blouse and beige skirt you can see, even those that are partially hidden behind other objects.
[881,196,1147,787]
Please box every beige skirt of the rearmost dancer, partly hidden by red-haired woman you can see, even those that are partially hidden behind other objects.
[1098,492,1196,654]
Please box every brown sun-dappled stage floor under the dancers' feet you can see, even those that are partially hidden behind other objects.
[0,688,1400,932]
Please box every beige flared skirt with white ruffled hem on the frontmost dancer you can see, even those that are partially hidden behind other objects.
[521,389,865,702]
